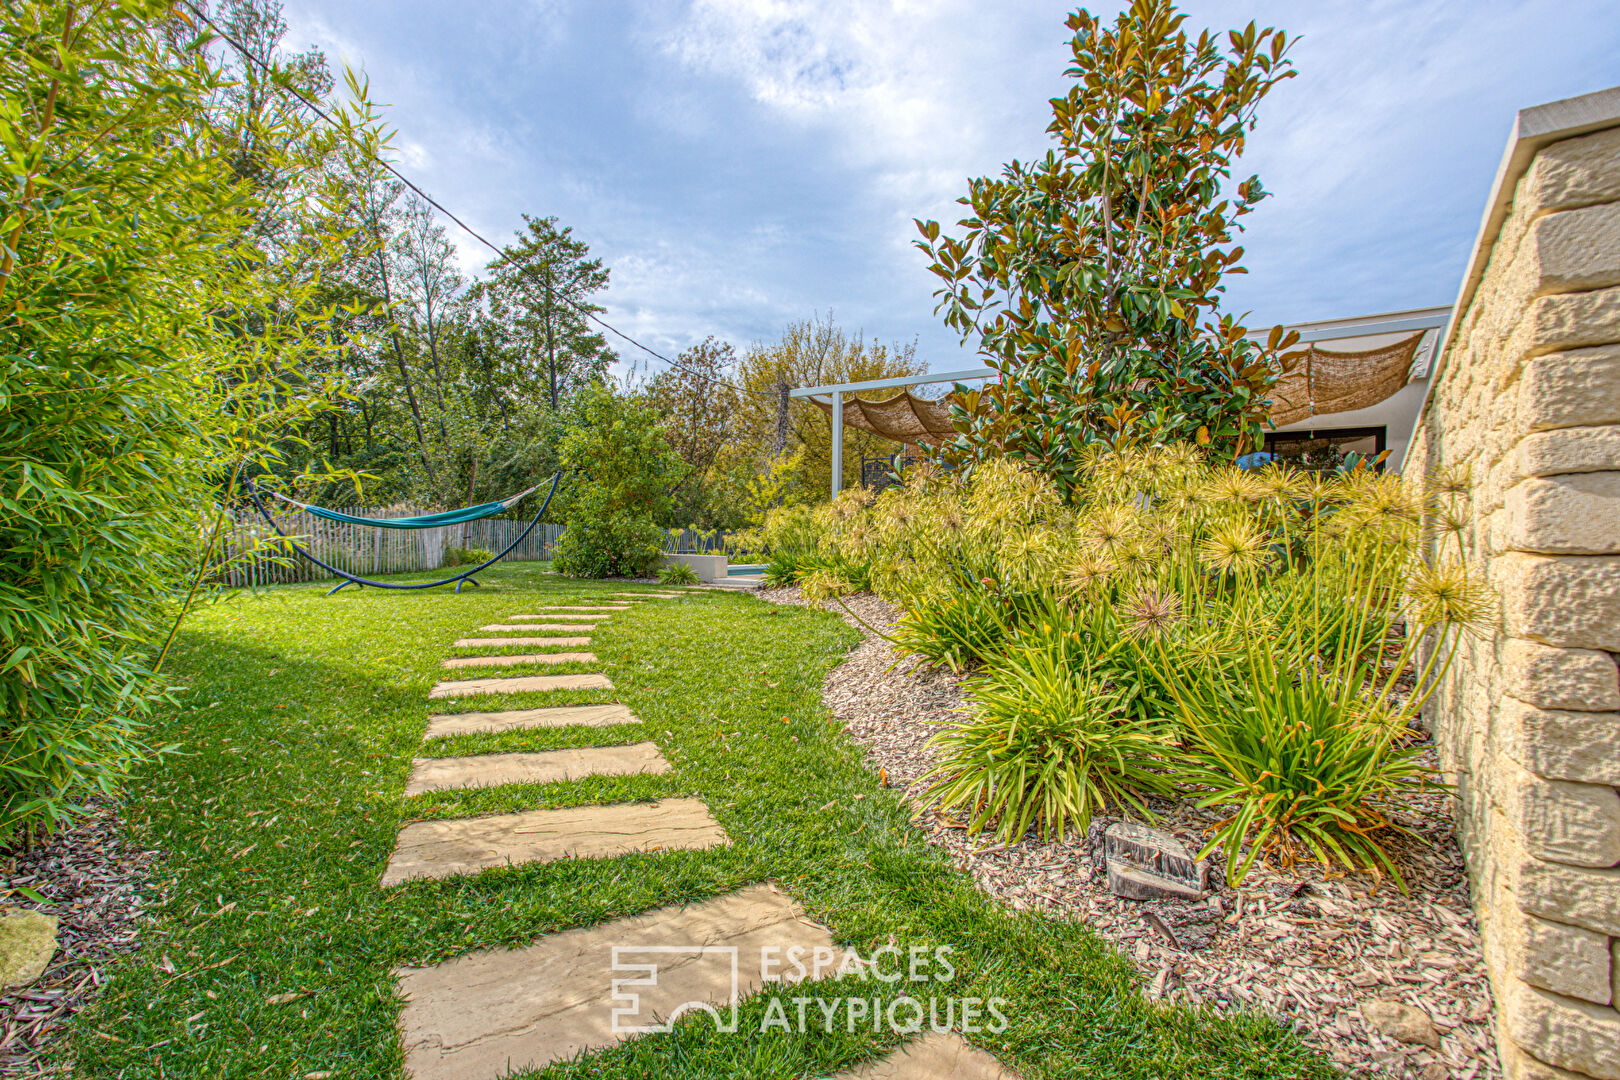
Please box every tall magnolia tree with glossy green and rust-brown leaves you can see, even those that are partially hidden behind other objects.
[917,0,1298,487]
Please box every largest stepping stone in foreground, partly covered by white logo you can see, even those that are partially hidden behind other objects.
[394,884,844,1080]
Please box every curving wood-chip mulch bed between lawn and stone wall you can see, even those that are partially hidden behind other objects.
[758,589,1502,1080]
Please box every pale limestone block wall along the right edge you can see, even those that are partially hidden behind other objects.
[1405,105,1620,1080]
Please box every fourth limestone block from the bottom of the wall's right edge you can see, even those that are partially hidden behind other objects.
[1495,763,1620,866]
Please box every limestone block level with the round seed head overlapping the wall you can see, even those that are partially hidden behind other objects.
[1492,552,1620,653]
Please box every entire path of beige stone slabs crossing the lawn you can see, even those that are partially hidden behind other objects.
[379,593,1016,1080]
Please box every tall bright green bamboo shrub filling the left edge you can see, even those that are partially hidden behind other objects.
[0,0,358,837]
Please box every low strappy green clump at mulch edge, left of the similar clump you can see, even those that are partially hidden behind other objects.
[927,648,1170,844]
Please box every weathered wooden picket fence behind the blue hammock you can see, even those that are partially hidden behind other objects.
[219,507,562,586]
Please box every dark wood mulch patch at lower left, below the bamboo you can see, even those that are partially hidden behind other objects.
[0,806,157,1077]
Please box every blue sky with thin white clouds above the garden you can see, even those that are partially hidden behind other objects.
[285,0,1620,380]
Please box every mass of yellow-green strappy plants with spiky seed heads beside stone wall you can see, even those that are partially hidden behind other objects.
[823,445,1492,887]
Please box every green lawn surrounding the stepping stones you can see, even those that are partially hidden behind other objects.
[63,565,1335,1080]
